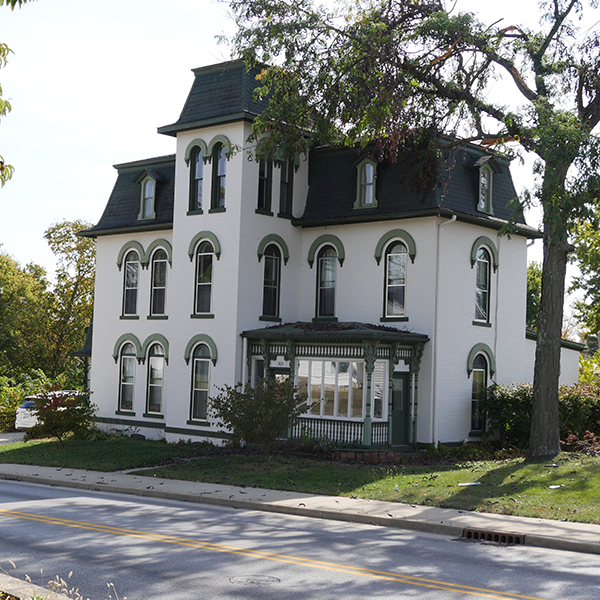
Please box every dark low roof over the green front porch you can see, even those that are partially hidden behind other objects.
[241,321,429,344]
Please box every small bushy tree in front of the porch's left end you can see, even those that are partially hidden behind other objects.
[211,379,307,466]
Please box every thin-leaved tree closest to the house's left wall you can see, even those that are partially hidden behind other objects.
[44,220,96,377]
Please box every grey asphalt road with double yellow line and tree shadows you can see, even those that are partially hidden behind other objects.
[0,481,600,600]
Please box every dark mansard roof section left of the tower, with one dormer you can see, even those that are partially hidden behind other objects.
[80,154,175,237]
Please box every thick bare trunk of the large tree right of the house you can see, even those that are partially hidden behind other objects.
[527,235,568,460]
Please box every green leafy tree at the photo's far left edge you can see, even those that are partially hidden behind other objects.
[0,250,52,376]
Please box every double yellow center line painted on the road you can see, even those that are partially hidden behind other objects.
[0,510,545,600]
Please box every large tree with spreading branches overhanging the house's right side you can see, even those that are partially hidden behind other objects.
[230,0,600,458]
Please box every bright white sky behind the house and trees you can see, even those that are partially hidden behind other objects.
[0,0,592,274]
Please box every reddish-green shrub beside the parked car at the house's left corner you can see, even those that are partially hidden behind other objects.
[26,390,96,446]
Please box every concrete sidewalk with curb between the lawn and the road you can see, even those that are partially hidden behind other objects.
[0,464,600,554]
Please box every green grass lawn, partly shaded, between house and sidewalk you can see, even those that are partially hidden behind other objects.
[0,438,600,524]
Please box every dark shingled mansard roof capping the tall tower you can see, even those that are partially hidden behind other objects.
[158,60,268,136]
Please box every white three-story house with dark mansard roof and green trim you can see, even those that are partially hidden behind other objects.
[83,61,579,448]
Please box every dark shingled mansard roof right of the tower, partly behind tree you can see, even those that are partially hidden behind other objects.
[294,146,538,237]
